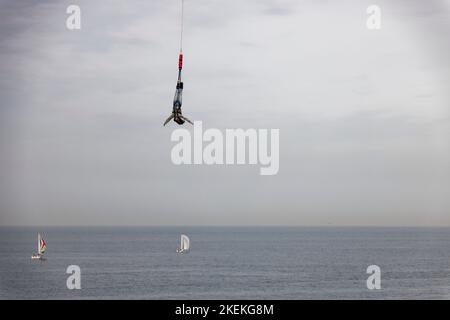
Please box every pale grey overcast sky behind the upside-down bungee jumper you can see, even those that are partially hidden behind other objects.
[0,0,450,226]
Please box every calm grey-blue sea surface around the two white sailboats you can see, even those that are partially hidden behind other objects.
[0,227,450,299]
